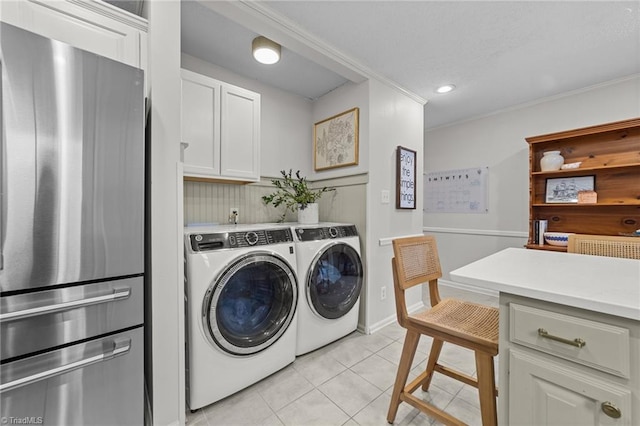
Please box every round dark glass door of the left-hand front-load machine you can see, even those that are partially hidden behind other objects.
[202,252,298,355]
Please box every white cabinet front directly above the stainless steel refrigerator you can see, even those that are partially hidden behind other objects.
[0,0,147,71]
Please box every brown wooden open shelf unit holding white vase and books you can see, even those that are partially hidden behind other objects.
[525,118,640,252]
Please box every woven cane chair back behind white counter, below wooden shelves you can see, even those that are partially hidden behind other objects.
[567,234,640,259]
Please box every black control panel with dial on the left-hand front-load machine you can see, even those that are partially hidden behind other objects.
[189,228,293,252]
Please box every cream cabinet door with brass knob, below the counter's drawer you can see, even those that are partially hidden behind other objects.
[509,350,634,426]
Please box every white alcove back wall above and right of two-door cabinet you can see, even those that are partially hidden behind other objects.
[182,54,312,177]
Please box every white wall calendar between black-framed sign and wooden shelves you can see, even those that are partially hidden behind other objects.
[423,167,489,213]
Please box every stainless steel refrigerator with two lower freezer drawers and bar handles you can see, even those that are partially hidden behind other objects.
[0,23,145,426]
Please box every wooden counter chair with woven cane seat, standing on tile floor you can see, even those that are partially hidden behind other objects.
[387,236,498,426]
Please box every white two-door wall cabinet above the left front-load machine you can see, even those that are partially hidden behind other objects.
[181,70,260,182]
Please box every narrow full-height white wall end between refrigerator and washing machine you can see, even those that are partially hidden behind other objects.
[145,1,185,425]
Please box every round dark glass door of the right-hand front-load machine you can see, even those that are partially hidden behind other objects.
[306,243,364,319]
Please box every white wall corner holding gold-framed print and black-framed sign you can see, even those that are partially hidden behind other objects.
[309,81,423,332]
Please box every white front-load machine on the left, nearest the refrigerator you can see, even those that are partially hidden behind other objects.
[185,224,298,410]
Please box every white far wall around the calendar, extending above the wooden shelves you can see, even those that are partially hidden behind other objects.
[424,75,640,281]
